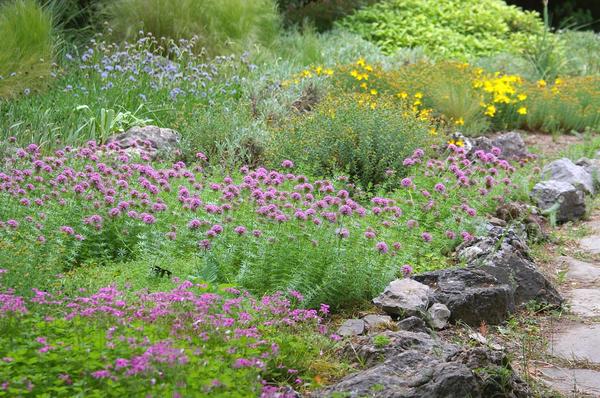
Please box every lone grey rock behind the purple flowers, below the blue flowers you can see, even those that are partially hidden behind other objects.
[108,126,180,157]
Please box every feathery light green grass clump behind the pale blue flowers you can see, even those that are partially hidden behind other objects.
[104,0,280,55]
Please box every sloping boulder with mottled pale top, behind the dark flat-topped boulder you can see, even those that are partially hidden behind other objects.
[458,227,562,306]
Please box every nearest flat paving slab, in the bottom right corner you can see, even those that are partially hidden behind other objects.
[542,368,600,397]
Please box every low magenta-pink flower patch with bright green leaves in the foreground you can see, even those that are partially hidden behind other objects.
[0,269,336,397]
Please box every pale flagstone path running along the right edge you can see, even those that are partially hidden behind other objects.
[541,216,600,397]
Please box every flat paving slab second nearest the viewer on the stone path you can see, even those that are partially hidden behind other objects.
[549,325,600,364]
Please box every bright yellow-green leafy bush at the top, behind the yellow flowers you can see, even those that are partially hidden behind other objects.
[340,0,543,60]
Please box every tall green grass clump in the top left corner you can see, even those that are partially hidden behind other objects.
[0,0,54,98]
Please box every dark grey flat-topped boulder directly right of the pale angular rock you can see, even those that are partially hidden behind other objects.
[415,267,515,326]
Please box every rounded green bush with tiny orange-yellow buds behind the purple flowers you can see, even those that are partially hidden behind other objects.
[268,94,431,189]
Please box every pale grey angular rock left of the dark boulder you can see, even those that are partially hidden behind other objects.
[373,278,431,317]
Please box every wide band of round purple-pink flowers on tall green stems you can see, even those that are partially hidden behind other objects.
[0,142,536,308]
